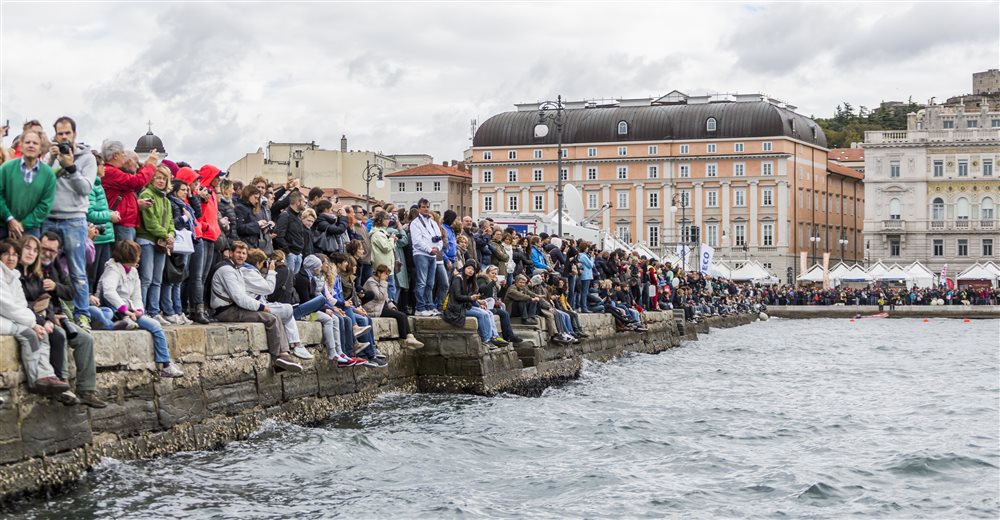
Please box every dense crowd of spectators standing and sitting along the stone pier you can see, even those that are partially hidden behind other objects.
[7,117,997,407]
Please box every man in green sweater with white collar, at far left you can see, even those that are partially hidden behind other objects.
[0,130,56,240]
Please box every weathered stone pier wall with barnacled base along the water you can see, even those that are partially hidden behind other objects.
[0,312,756,502]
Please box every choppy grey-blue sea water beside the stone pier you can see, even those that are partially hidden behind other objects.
[12,319,1000,518]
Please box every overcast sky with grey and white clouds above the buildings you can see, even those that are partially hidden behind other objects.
[0,0,1000,167]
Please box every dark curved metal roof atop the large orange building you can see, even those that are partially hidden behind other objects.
[472,101,826,148]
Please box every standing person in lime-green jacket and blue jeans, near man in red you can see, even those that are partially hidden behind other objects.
[136,165,174,326]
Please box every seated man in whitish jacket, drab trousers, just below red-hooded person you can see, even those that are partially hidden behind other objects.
[209,240,302,372]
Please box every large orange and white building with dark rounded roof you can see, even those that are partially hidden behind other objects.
[471,91,864,281]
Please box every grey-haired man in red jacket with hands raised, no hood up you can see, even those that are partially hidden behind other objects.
[101,141,159,241]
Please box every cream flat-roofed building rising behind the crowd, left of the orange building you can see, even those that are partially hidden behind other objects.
[229,137,433,200]
